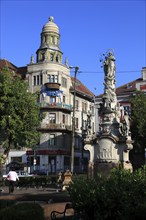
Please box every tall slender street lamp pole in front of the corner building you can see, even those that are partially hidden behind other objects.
[70,66,79,174]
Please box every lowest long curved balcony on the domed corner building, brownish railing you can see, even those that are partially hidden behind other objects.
[38,123,72,133]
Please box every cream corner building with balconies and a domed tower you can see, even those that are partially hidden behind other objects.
[26,17,95,173]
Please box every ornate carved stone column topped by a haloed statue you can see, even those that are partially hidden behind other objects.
[84,51,133,175]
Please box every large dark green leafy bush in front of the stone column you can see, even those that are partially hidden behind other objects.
[68,167,146,220]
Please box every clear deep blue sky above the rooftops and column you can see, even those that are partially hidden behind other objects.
[0,0,146,95]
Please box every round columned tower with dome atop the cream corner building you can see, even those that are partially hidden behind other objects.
[36,16,63,63]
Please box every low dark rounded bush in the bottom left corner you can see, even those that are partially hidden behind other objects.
[0,203,44,220]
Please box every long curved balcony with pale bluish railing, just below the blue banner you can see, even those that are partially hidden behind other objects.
[39,102,72,112]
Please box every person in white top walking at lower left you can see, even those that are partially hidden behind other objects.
[7,168,19,193]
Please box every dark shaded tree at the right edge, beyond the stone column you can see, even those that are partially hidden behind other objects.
[131,91,146,168]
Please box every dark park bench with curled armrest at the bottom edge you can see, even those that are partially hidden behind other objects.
[51,203,73,220]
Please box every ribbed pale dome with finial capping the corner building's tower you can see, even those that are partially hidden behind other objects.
[42,16,59,34]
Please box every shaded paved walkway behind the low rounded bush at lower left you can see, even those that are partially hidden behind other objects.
[0,187,73,220]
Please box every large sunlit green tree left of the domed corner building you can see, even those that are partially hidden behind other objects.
[0,68,40,162]
